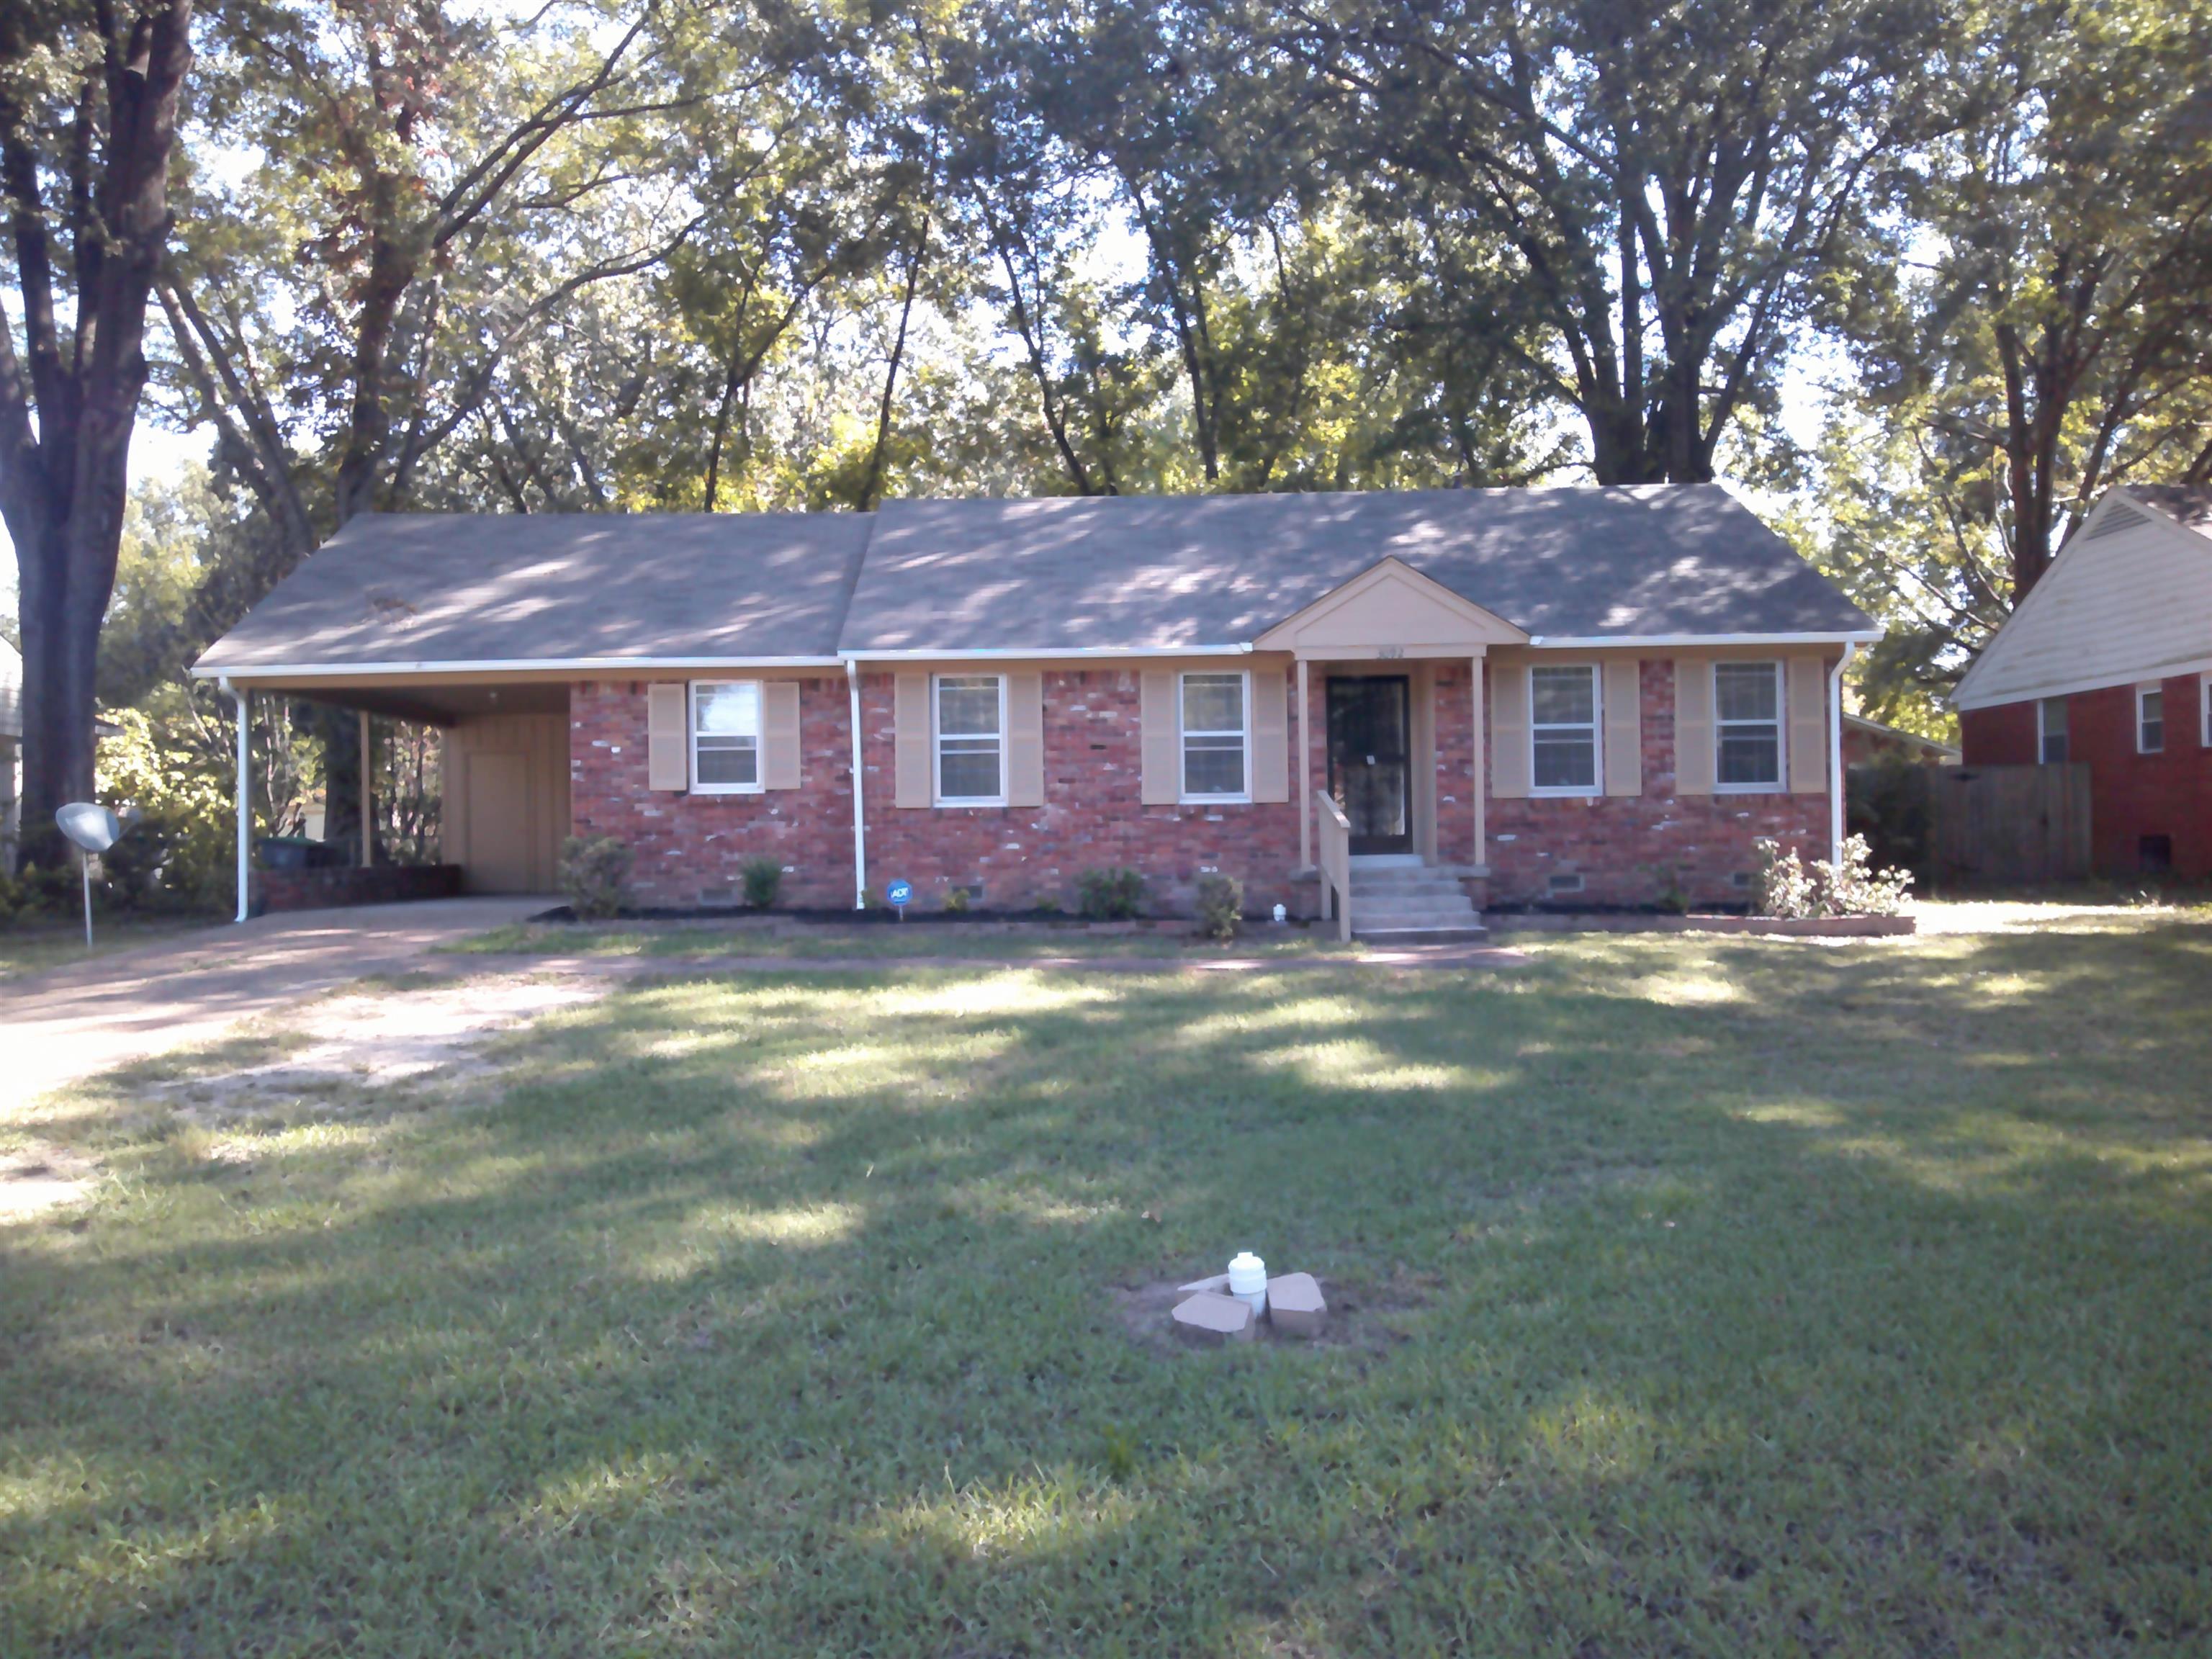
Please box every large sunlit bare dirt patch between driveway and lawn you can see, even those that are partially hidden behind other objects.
[161,974,613,1126]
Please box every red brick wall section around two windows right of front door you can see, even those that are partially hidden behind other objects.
[1488,659,1830,904]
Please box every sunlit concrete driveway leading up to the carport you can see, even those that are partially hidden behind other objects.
[0,898,559,1117]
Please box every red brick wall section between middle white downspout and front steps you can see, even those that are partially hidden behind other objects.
[860,668,1298,909]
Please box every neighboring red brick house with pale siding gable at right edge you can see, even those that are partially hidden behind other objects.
[1954,485,2212,881]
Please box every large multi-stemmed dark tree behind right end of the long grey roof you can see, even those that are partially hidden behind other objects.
[1252,0,1940,485]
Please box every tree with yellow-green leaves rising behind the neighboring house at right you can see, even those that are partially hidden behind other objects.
[1856,0,2212,619]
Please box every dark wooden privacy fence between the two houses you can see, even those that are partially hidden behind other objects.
[1915,765,2090,887]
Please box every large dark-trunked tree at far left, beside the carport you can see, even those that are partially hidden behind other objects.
[0,0,192,848]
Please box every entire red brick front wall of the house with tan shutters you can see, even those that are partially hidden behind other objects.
[569,659,1827,912]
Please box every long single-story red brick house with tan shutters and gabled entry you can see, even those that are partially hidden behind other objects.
[192,485,1878,931]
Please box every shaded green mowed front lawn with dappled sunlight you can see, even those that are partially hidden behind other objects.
[0,920,2212,1659]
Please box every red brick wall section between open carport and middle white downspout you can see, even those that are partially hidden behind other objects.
[569,675,852,909]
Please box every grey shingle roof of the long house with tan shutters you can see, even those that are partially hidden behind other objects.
[199,485,1874,673]
